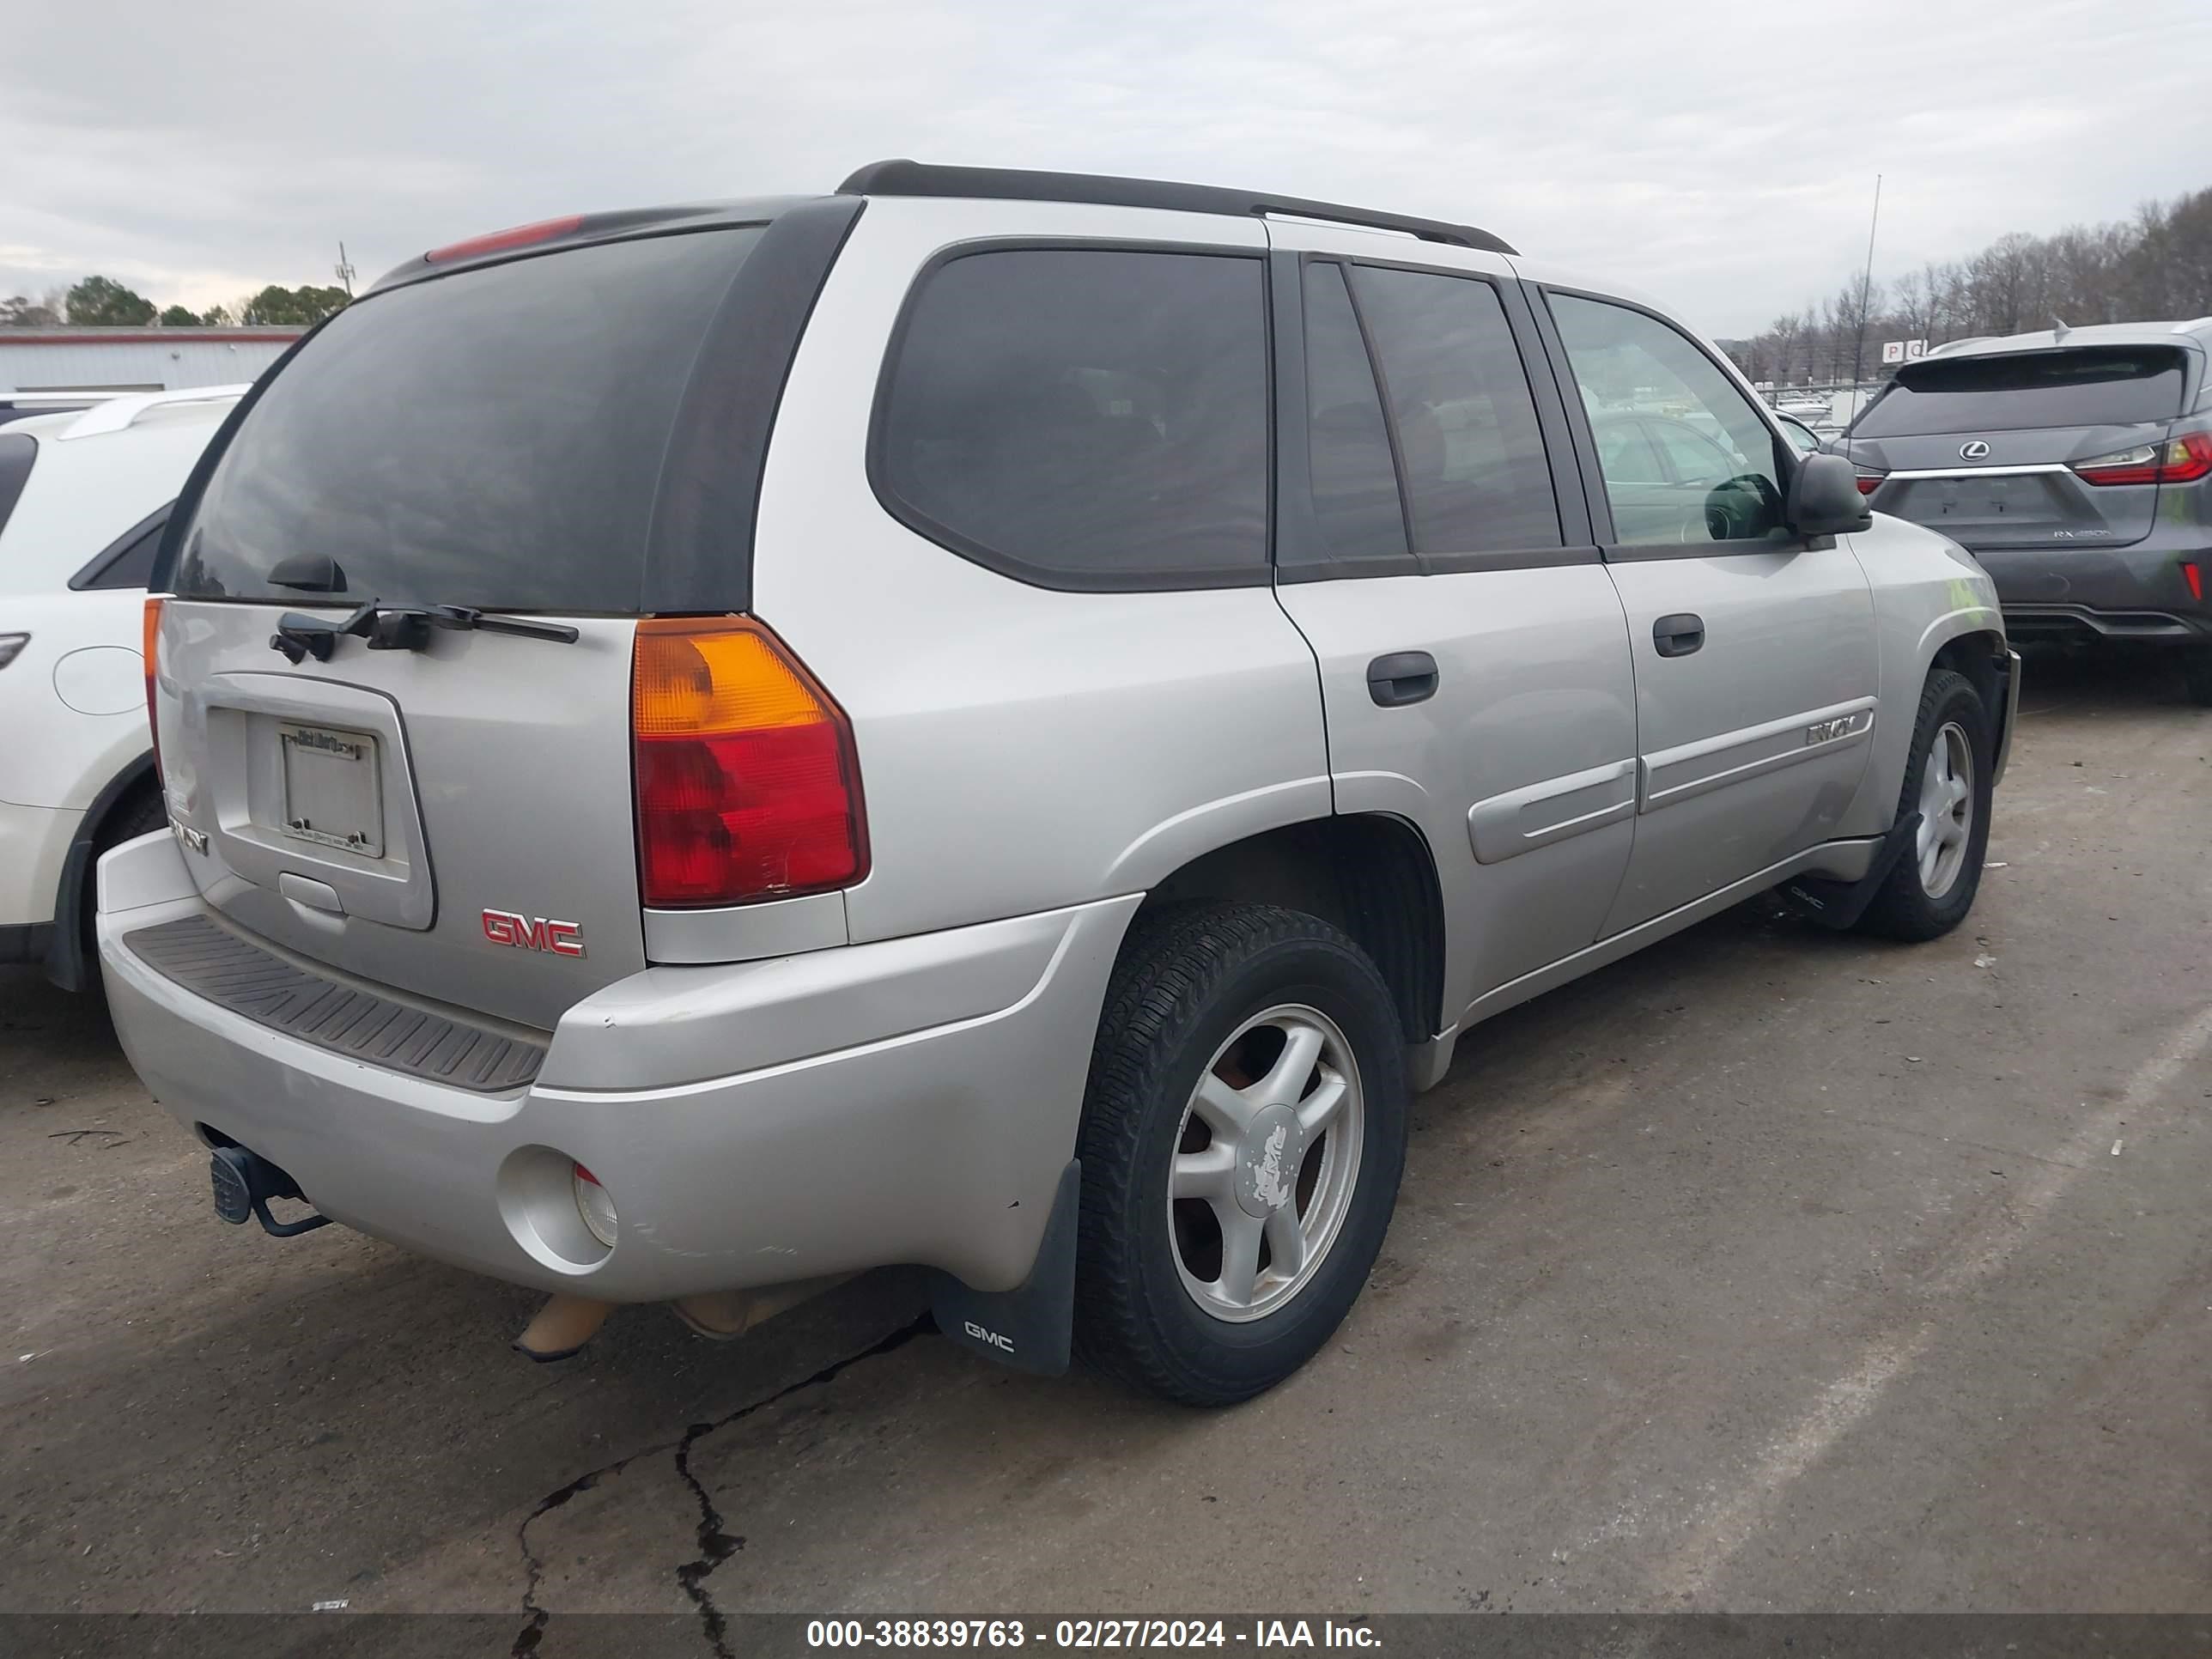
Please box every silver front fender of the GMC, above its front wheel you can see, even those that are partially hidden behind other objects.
[1836,514,2004,836]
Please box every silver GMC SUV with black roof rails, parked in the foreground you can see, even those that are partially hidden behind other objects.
[97,161,2017,1402]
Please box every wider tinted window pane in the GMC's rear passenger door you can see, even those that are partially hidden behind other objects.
[1352,265,1562,553]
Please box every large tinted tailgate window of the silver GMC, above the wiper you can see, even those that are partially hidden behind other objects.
[175,228,761,613]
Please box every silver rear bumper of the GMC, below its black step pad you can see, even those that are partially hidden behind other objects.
[97,834,1139,1301]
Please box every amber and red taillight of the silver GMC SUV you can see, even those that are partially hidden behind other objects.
[630,617,867,905]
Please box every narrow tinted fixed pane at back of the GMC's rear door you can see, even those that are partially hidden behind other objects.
[1305,264,1407,560]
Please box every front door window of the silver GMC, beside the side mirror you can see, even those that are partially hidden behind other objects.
[1551,295,1783,546]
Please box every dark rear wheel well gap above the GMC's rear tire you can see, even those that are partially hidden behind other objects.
[1139,811,1444,1044]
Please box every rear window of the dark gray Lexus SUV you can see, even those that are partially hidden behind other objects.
[1851,347,2181,438]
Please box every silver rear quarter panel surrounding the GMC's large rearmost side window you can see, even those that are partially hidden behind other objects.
[754,199,1329,942]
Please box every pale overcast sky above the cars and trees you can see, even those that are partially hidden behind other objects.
[0,0,2212,334]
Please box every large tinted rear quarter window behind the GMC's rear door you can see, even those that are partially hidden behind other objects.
[876,248,1267,586]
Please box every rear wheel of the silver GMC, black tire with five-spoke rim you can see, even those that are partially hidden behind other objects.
[1075,905,1407,1405]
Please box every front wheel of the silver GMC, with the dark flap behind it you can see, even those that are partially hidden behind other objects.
[1858,668,1993,942]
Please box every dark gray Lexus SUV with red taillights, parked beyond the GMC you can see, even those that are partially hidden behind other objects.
[1832,316,2212,706]
